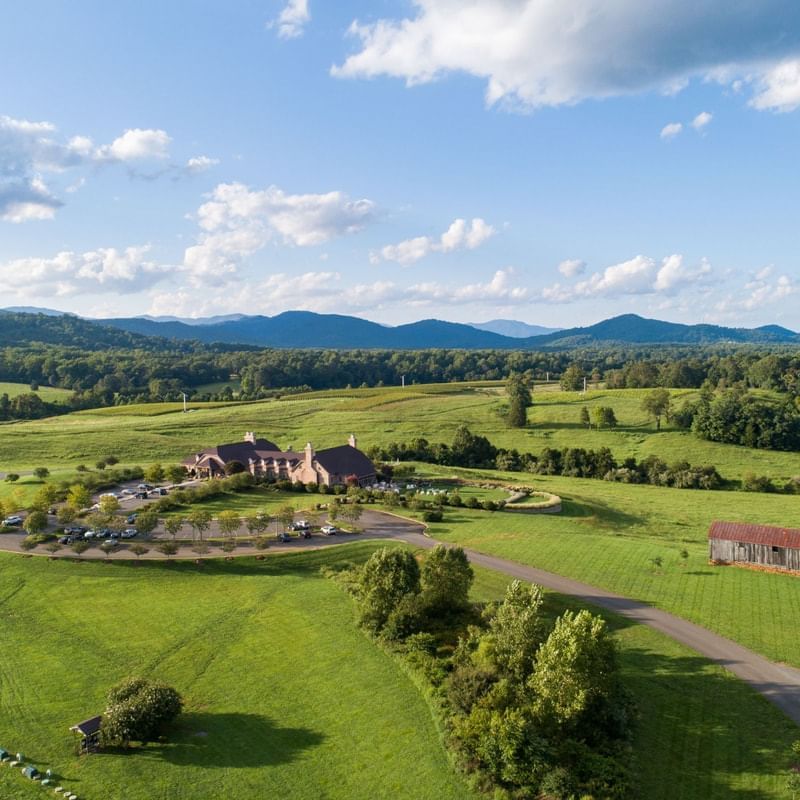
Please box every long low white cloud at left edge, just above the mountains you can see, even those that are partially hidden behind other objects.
[0,245,172,297]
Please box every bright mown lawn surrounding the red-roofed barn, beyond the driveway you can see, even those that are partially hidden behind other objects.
[412,466,800,667]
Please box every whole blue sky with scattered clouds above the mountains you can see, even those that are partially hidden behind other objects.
[0,0,800,329]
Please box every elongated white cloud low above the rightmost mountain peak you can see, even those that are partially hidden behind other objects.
[541,255,711,303]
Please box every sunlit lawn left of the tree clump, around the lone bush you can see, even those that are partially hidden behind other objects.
[0,545,470,800]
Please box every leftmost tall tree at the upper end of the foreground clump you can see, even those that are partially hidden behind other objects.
[359,547,419,633]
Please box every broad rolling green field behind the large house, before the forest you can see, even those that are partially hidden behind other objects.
[0,382,800,481]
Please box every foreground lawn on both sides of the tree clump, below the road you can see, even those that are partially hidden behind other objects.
[0,542,797,800]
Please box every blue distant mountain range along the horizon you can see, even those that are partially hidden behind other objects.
[0,309,800,350]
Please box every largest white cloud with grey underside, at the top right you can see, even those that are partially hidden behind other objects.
[332,0,800,108]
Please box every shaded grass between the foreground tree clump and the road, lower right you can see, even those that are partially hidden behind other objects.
[473,568,798,800]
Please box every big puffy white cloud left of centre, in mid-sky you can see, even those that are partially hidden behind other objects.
[184,183,376,285]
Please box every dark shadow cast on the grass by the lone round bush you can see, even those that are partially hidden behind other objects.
[104,712,325,769]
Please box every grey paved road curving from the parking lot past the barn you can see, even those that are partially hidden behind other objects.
[0,509,800,725]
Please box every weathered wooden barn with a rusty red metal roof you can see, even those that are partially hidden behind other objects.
[708,522,800,572]
